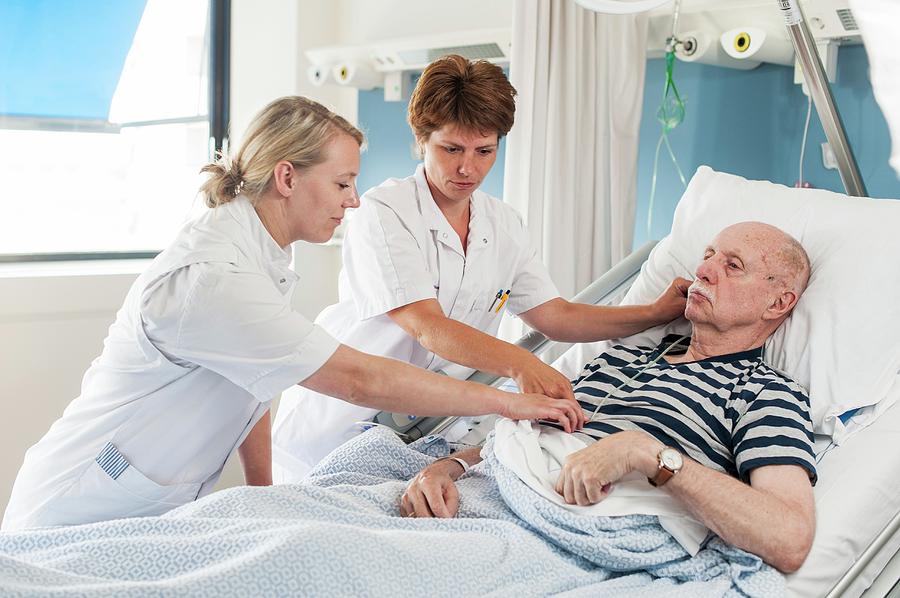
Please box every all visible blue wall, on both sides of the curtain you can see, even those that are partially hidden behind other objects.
[359,45,900,246]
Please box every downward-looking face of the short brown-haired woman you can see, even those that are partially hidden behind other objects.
[419,125,499,203]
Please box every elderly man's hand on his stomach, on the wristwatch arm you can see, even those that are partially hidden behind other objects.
[556,431,662,507]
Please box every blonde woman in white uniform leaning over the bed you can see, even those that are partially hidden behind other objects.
[3,97,583,530]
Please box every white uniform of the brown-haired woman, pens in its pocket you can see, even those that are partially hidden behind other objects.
[272,165,559,483]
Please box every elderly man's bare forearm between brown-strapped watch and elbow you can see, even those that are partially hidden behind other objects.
[652,459,815,572]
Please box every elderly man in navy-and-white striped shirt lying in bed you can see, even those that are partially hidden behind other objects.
[400,222,816,572]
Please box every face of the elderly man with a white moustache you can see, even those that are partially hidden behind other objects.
[684,224,780,332]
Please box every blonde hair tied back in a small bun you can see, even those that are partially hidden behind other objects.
[200,96,364,208]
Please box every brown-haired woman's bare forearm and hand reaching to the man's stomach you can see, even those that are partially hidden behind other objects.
[387,299,575,401]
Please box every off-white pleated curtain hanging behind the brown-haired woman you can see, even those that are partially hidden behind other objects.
[503,0,647,297]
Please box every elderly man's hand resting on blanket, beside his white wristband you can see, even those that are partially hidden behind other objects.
[400,459,463,518]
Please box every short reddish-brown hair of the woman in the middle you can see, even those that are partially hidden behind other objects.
[408,54,516,139]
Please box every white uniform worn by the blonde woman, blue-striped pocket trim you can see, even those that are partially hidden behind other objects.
[3,197,338,529]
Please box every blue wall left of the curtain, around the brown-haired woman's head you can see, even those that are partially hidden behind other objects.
[356,89,506,198]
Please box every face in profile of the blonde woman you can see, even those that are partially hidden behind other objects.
[289,134,359,243]
